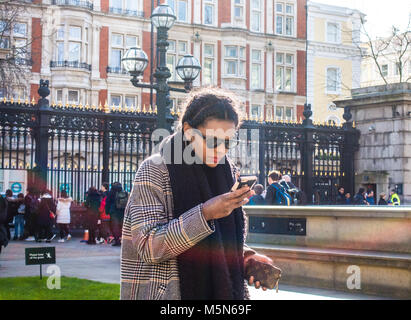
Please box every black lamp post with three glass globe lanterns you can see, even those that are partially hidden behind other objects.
[121,4,201,132]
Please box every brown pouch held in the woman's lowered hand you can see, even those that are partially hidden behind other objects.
[245,259,281,292]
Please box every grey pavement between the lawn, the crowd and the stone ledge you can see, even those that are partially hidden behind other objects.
[0,237,392,300]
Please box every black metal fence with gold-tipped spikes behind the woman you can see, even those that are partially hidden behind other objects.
[0,81,359,204]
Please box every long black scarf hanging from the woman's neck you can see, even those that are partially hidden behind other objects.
[162,132,244,300]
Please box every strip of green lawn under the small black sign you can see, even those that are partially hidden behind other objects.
[0,277,120,300]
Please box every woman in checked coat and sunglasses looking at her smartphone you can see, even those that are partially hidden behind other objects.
[121,88,280,300]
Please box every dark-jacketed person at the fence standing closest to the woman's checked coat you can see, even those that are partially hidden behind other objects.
[106,182,124,246]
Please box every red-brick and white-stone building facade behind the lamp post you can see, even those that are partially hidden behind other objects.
[0,0,306,121]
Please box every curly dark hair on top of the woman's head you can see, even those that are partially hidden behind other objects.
[178,87,243,130]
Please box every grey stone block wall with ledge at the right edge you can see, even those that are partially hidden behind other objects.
[335,83,411,204]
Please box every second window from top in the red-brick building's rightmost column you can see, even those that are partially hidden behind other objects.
[275,53,295,92]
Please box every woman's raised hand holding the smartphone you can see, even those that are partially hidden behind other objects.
[203,186,252,221]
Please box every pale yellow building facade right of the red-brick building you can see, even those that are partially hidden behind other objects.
[307,1,364,125]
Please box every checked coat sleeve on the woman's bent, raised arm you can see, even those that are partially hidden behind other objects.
[123,159,214,263]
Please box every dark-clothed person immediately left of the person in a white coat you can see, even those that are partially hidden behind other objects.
[36,190,56,242]
